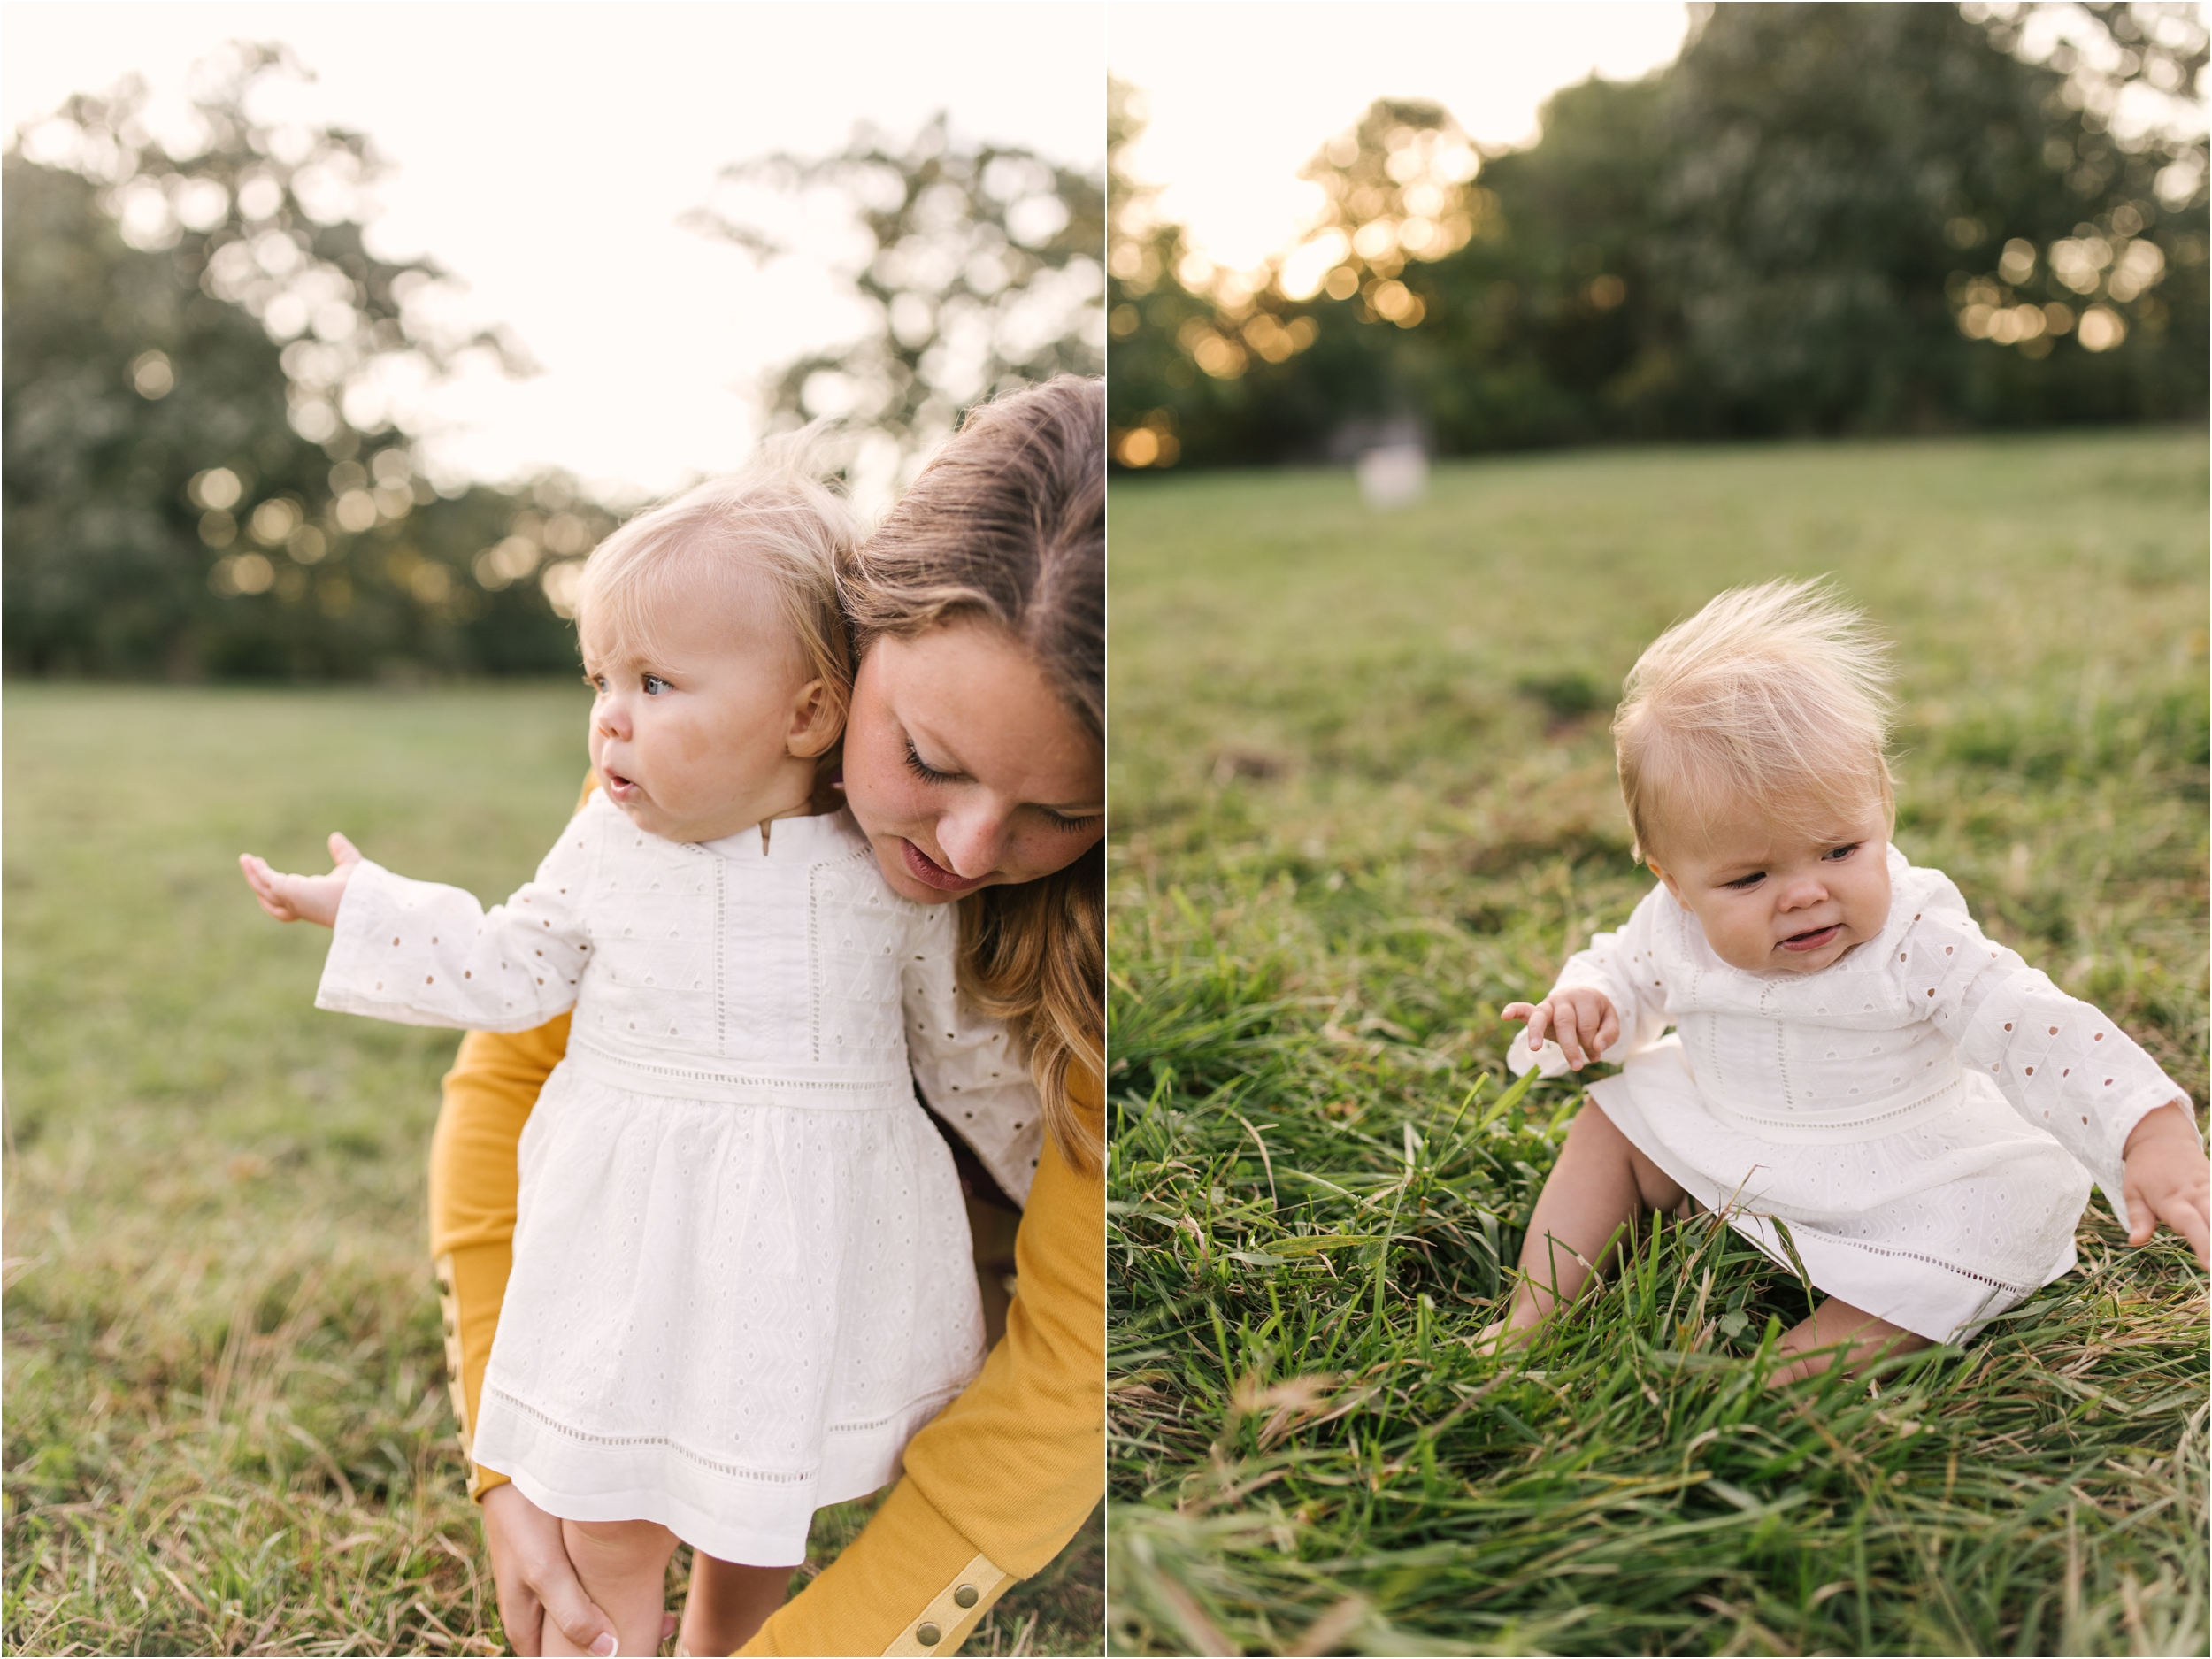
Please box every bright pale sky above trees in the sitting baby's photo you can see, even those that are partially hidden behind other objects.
[1106,0,1690,270]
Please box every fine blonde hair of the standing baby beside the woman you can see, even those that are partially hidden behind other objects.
[575,423,867,719]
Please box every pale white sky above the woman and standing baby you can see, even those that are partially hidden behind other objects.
[0,0,1106,494]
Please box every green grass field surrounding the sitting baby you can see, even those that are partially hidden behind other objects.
[1109,432,2208,1655]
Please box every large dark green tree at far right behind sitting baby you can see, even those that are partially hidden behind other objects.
[1655,4,2203,432]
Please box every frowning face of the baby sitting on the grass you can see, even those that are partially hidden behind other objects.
[1650,801,1889,973]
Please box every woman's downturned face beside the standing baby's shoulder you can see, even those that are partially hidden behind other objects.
[845,622,1106,905]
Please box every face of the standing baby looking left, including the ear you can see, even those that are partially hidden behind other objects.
[582,595,836,841]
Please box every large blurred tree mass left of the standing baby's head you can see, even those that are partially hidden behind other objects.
[0,47,613,677]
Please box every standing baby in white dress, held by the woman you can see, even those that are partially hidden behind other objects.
[242,451,1040,1653]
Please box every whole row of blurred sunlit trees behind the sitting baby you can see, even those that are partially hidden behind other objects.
[1109,4,2208,467]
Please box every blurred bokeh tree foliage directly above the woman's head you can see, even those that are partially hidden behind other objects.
[690,115,1106,480]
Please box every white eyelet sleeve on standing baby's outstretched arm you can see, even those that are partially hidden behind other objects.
[314,826,593,1031]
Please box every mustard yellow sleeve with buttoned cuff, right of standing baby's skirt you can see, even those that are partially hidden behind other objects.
[743,1079,1106,1655]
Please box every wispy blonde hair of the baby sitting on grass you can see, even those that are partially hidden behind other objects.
[1613,578,1896,863]
